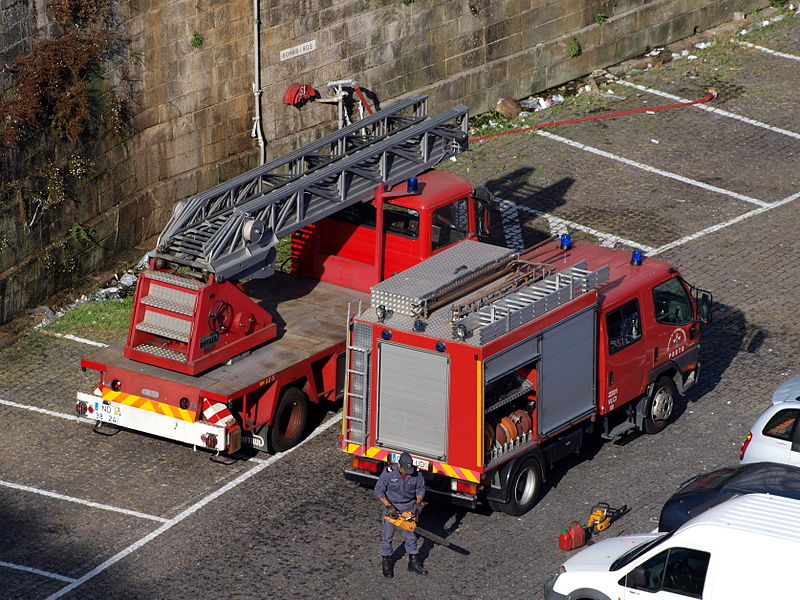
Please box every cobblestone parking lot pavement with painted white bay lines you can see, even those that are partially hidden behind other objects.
[0,11,800,600]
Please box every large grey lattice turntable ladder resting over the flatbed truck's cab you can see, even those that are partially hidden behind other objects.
[156,95,468,280]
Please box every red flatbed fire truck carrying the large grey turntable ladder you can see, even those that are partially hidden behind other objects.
[76,95,488,453]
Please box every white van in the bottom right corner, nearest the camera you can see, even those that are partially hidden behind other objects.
[544,494,800,600]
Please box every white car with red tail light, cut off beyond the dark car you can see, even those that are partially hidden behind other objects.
[739,400,800,467]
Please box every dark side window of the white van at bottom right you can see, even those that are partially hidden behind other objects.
[619,548,711,598]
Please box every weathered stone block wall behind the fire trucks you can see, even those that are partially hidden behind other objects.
[0,0,768,322]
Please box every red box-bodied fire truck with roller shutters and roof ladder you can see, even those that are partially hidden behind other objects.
[341,235,711,515]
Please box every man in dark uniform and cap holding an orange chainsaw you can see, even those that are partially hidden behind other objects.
[375,452,428,577]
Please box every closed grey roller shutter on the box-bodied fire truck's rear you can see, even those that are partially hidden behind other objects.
[377,342,450,460]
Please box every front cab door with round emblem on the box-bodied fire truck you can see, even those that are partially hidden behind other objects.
[644,276,698,367]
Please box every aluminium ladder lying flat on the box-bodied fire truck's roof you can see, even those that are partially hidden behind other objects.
[453,261,609,344]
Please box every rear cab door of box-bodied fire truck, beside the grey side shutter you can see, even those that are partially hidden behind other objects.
[600,298,649,412]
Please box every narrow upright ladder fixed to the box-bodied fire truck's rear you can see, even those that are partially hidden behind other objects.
[343,300,372,446]
